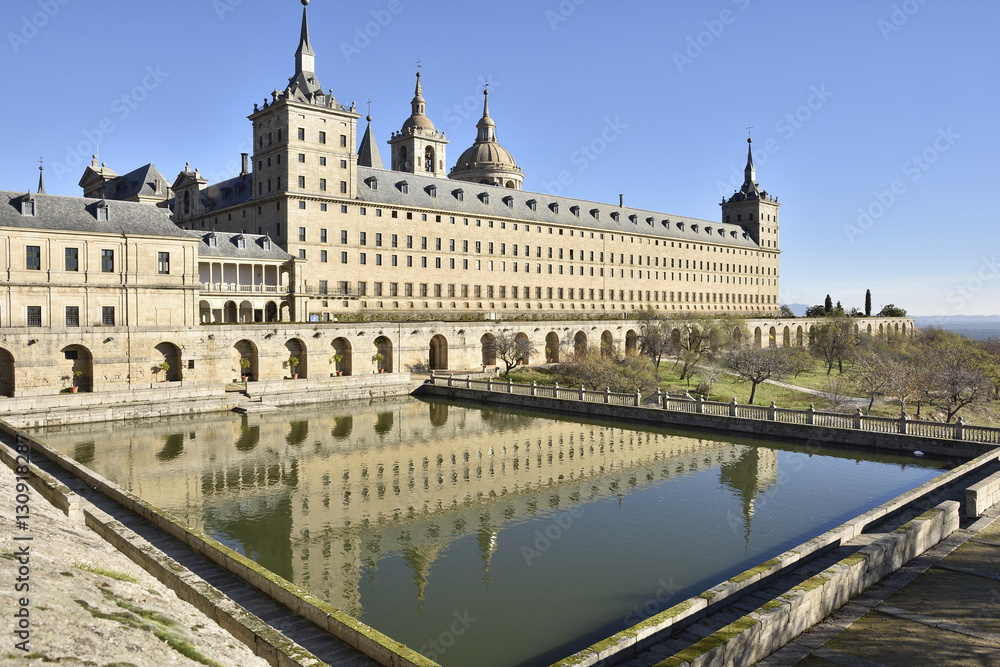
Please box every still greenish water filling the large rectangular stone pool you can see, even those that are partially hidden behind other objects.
[31,398,948,667]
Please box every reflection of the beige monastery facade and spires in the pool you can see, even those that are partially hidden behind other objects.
[37,399,777,615]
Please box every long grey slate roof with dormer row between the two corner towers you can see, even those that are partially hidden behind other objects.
[357,166,759,249]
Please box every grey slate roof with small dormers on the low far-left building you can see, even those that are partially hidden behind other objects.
[0,190,190,237]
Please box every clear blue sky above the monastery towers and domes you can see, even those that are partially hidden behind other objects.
[0,0,1000,315]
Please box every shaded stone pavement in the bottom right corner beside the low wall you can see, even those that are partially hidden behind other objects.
[757,505,1000,667]
